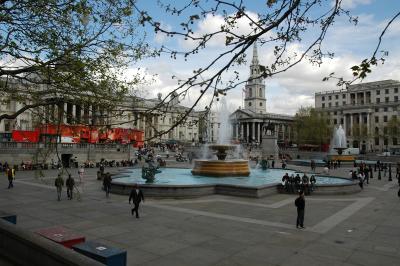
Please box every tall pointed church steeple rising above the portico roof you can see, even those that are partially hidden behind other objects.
[244,42,267,114]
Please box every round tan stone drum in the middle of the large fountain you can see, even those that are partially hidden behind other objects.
[192,160,250,177]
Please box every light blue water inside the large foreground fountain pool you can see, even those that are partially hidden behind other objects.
[113,168,352,187]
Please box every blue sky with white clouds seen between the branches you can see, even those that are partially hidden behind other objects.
[127,0,400,115]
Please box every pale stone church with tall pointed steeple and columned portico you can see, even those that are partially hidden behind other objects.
[230,45,294,143]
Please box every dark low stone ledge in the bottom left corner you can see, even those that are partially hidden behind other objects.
[0,220,103,266]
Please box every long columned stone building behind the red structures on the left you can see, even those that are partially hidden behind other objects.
[0,80,207,142]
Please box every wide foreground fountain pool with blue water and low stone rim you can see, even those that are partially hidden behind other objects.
[111,168,361,198]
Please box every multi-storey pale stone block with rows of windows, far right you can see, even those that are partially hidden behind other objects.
[315,80,400,151]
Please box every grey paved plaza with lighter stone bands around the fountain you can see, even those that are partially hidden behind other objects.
[0,165,400,266]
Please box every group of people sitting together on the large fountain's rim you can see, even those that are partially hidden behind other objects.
[282,173,317,195]
